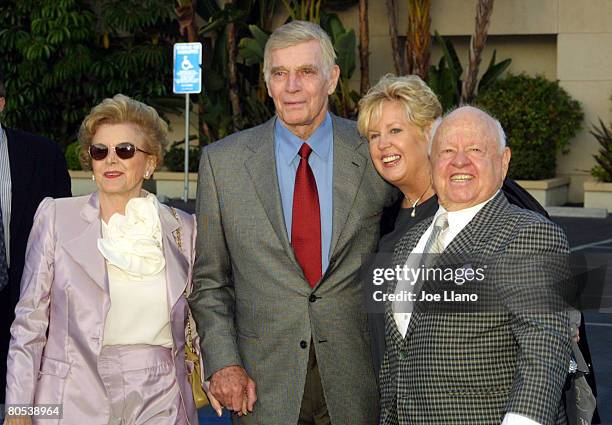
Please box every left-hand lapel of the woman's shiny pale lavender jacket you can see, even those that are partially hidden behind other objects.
[64,192,108,293]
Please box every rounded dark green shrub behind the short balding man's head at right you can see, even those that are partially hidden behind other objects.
[475,75,584,180]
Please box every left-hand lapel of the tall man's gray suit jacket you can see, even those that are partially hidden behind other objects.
[244,118,302,273]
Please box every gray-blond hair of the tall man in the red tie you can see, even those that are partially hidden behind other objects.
[263,21,336,84]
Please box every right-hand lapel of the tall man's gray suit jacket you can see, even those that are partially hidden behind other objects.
[330,115,369,259]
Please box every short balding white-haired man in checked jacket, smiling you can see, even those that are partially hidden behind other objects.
[381,107,570,425]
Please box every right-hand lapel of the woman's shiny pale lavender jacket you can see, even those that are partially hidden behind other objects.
[159,204,191,310]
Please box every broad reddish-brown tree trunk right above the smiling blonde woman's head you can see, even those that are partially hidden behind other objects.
[404,0,431,80]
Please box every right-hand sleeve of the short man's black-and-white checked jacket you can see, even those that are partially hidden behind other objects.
[500,220,571,425]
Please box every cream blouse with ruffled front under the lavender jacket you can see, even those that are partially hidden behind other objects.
[98,194,172,347]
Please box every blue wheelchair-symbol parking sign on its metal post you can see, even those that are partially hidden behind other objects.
[172,43,202,202]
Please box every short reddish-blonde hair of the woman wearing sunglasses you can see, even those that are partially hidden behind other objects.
[78,94,168,169]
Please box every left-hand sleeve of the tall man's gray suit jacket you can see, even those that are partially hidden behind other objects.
[188,149,242,378]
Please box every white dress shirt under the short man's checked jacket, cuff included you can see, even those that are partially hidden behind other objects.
[393,191,541,425]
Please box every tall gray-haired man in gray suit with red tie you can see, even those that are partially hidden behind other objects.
[189,21,393,425]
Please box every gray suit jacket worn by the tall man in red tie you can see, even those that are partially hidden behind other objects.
[189,116,394,425]
